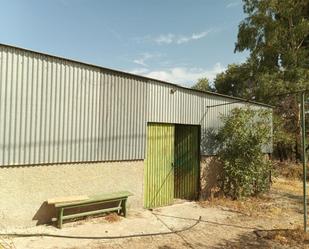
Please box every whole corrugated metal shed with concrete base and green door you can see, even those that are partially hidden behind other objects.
[0,44,271,226]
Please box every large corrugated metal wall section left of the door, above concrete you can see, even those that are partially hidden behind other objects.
[0,46,147,165]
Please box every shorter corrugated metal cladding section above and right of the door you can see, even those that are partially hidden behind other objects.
[147,81,271,155]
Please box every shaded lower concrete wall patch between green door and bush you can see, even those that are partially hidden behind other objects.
[200,156,223,200]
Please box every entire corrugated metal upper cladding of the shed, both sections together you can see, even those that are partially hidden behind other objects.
[0,45,271,165]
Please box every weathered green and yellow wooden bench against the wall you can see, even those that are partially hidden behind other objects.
[54,191,132,229]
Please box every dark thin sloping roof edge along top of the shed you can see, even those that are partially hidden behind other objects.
[0,42,274,108]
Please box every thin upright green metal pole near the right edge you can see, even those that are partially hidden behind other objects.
[301,92,307,232]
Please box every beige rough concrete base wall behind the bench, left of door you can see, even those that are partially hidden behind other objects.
[0,161,144,227]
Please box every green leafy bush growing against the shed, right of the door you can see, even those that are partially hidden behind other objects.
[218,108,271,198]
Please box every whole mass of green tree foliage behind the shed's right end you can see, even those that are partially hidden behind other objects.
[214,0,309,159]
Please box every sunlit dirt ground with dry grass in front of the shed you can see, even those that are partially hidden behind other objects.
[0,178,309,249]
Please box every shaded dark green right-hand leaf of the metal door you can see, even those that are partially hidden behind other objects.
[174,125,199,200]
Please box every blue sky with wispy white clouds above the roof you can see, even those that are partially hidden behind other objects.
[0,0,247,86]
